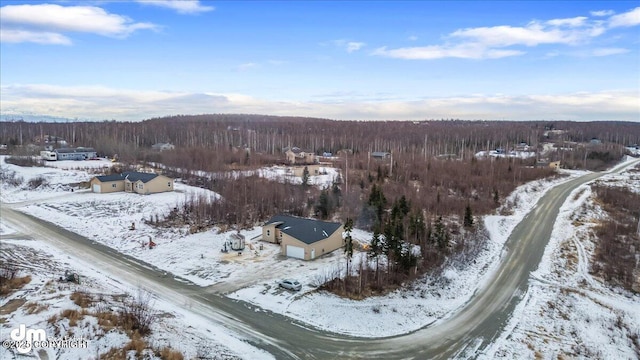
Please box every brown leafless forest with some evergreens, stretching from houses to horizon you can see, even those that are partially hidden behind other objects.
[0,114,640,297]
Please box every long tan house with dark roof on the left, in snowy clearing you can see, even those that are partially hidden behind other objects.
[90,171,173,195]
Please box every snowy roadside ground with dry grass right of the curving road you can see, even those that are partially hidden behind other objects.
[481,159,640,359]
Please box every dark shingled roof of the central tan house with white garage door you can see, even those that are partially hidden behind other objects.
[266,215,342,244]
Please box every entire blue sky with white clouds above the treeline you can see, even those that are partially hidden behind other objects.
[0,0,640,121]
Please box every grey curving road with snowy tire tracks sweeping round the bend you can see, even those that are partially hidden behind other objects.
[1,160,639,359]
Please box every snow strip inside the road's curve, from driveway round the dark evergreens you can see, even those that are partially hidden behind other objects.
[229,167,583,337]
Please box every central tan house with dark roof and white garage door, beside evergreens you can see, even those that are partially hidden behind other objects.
[262,215,344,260]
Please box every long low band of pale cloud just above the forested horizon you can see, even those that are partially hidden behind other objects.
[0,85,640,121]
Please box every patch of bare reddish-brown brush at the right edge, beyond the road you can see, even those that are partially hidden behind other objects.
[591,184,640,292]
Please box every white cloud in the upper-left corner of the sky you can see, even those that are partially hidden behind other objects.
[0,4,157,45]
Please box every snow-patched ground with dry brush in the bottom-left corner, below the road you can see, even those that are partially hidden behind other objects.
[0,224,272,360]
